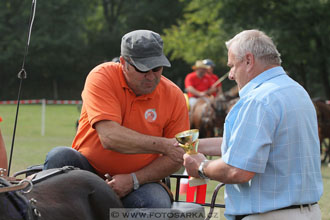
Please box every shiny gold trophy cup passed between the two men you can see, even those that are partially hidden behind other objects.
[175,129,208,186]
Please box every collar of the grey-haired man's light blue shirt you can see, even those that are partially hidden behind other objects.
[239,66,286,98]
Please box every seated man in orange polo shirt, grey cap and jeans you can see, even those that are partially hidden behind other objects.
[45,30,189,208]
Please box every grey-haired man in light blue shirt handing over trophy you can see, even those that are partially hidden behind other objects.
[184,30,323,220]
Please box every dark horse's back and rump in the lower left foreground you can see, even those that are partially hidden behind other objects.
[0,169,123,220]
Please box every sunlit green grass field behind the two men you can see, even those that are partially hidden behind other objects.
[0,105,330,220]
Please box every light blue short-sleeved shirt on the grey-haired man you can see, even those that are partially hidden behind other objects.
[221,67,323,219]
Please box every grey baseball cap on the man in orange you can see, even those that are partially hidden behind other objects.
[121,30,171,71]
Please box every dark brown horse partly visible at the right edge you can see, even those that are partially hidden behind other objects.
[313,99,330,163]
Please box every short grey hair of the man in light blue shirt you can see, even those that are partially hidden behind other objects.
[226,30,282,65]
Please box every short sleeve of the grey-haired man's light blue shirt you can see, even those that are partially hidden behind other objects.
[222,100,277,173]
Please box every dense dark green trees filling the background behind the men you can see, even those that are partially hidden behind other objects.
[0,0,330,100]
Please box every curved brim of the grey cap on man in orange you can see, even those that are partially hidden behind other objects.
[130,54,171,71]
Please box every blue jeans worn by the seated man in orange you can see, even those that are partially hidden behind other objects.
[44,147,171,208]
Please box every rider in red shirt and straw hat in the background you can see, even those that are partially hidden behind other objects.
[185,60,216,109]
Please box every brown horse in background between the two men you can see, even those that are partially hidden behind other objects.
[190,86,238,138]
